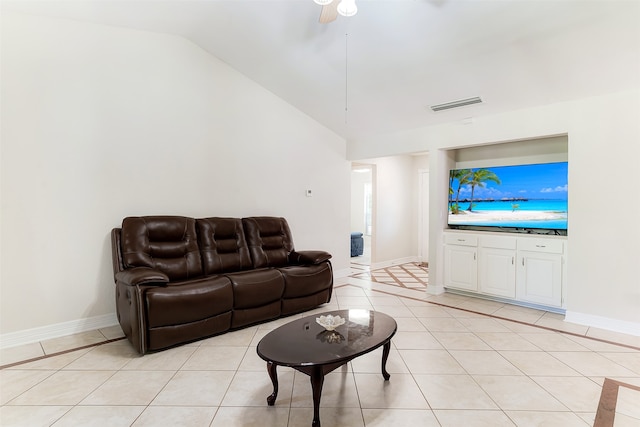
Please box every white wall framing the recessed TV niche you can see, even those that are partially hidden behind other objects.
[347,88,640,334]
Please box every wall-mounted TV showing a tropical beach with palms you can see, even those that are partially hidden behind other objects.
[448,162,568,235]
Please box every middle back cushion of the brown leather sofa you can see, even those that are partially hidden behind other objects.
[196,218,252,275]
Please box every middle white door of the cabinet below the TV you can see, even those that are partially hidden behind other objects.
[478,248,516,298]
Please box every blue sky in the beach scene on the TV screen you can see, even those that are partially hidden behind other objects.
[453,162,568,200]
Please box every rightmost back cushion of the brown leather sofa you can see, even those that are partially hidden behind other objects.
[242,216,294,268]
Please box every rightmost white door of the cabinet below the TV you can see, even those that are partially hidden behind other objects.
[516,252,562,307]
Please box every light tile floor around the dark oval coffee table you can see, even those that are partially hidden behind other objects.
[0,266,640,427]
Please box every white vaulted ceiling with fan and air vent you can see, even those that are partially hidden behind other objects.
[3,0,640,140]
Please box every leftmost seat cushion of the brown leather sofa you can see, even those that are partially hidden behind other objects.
[145,276,233,328]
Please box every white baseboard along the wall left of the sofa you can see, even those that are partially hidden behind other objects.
[0,313,118,349]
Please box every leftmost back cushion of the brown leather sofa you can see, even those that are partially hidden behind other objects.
[121,216,202,281]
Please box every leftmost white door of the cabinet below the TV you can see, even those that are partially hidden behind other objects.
[444,245,478,291]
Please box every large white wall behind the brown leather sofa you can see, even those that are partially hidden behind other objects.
[0,13,350,342]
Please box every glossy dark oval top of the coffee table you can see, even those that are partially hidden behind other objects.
[257,309,397,367]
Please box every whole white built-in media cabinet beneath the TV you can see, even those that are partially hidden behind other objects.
[443,230,567,313]
